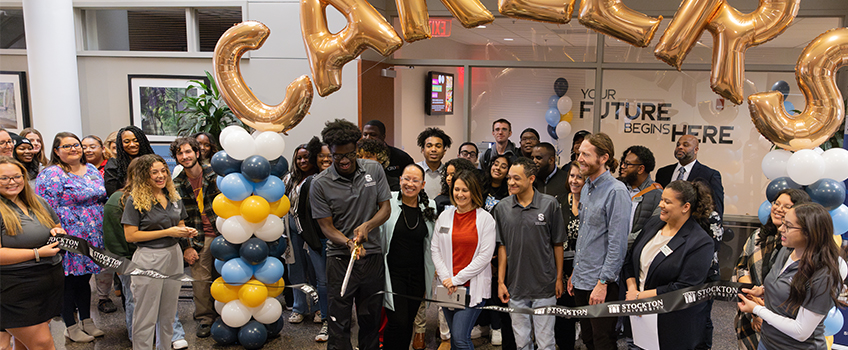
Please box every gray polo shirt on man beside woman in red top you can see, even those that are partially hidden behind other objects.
[492,190,566,300]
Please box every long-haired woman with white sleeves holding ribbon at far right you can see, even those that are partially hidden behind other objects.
[738,203,842,350]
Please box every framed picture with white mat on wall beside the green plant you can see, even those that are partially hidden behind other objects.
[128,75,209,142]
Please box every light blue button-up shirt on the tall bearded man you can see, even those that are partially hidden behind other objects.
[571,171,631,290]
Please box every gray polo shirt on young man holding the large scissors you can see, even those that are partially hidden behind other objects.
[309,159,391,256]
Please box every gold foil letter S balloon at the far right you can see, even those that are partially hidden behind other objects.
[748,28,848,151]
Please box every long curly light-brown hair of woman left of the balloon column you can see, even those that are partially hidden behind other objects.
[121,154,181,212]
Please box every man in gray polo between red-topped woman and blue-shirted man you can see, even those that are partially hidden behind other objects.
[492,157,566,350]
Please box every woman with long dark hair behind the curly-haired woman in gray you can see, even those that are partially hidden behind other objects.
[103,125,153,196]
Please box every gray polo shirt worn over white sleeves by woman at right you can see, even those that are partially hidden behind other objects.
[761,247,834,349]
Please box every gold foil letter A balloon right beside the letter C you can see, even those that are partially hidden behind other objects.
[300,0,404,96]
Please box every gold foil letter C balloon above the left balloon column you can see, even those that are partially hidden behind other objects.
[212,21,312,132]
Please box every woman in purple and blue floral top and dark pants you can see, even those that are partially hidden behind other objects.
[36,132,106,342]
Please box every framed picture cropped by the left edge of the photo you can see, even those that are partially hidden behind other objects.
[0,71,30,132]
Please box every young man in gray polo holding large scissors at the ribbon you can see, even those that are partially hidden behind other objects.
[309,119,391,350]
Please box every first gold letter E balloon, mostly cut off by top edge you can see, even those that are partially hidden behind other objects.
[498,0,575,24]
